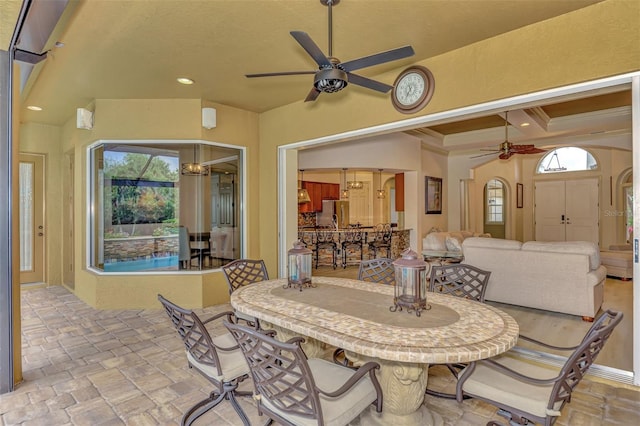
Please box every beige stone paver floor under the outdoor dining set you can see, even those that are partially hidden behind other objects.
[0,287,640,426]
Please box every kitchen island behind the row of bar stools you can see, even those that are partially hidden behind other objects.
[298,226,411,266]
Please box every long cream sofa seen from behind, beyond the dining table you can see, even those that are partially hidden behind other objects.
[462,238,607,319]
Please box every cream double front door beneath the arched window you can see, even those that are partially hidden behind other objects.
[535,178,599,244]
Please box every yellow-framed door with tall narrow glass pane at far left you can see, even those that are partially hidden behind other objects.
[19,154,46,284]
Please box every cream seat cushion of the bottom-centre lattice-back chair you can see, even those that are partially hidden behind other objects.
[261,358,377,426]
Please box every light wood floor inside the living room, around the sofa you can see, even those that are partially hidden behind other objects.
[313,266,633,372]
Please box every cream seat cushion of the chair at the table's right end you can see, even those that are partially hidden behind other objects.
[459,355,562,418]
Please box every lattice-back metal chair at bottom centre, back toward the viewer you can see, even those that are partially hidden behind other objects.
[224,322,383,426]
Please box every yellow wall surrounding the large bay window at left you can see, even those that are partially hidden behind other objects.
[21,99,260,309]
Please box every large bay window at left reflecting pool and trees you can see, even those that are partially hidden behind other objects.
[88,141,244,273]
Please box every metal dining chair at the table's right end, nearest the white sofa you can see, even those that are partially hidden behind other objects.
[456,310,623,426]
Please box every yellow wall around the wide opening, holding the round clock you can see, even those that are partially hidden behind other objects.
[260,0,640,269]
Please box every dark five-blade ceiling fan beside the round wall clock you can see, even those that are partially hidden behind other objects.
[246,0,414,102]
